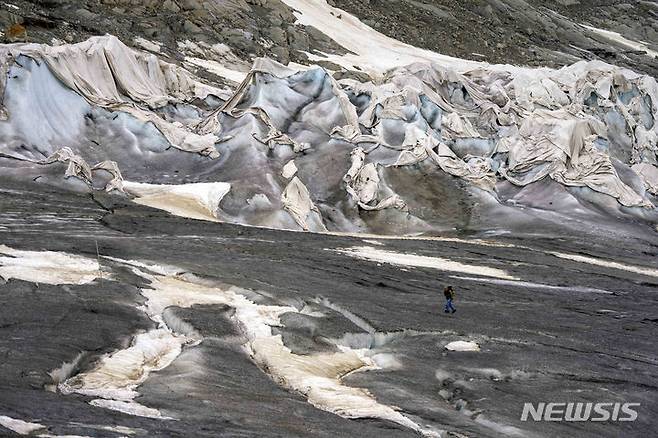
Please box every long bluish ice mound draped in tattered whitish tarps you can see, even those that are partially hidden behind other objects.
[0,30,658,234]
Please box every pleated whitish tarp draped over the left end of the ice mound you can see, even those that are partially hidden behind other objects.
[0,35,224,158]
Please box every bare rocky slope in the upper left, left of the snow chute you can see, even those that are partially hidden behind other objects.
[0,0,341,70]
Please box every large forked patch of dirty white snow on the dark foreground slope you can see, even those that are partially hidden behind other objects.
[72,259,435,436]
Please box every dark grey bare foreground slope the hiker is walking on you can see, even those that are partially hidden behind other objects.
[0,177,658,437]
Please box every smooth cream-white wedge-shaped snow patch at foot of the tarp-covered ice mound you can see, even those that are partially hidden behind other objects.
[123,181,231,222]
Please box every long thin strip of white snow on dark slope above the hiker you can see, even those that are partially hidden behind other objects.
[335,246,518,280]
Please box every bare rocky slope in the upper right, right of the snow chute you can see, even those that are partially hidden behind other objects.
[335,0,658,76]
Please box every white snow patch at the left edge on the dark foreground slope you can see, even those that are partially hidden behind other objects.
[0,245,100,284]
